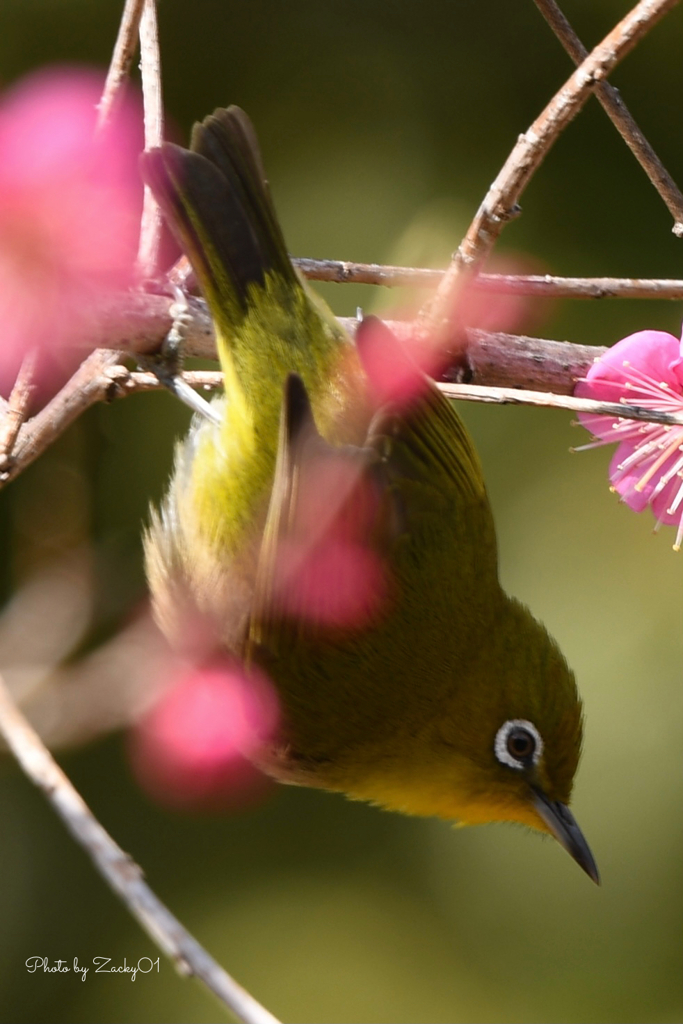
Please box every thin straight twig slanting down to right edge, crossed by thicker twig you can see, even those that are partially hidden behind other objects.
[535,0,683,239]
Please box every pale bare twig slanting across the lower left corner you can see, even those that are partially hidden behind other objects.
[0,679,278,1024]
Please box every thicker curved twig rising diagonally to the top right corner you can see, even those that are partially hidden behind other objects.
[418,0,678,336]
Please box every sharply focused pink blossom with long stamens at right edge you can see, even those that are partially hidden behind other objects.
[574,331,683,551]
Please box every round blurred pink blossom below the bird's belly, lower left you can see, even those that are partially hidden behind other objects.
[130,665,280,809]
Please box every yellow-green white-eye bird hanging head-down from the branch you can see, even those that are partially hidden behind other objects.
[143,106,598,882]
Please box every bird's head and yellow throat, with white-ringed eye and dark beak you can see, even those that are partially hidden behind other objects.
[353,596,599,883]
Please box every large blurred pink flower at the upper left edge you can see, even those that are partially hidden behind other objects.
[0,68,141,385]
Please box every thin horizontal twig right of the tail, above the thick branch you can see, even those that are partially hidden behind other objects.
[292,256,683,301]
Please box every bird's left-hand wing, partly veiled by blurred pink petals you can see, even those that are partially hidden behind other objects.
[249,374,392,646]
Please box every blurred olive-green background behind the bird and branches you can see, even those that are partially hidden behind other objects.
[0,0,683,1024]
